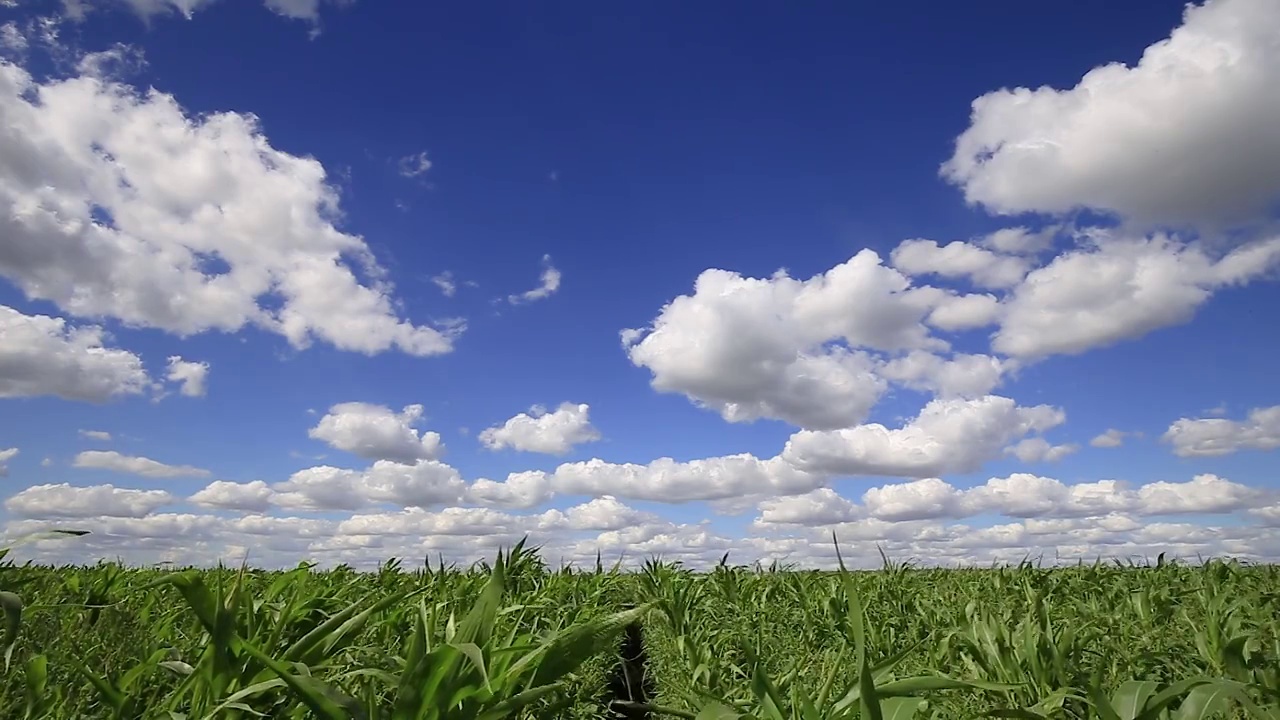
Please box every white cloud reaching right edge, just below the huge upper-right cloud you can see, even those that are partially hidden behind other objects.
[992,231,1280,357]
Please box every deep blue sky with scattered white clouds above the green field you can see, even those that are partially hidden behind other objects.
[0,0,1280,568]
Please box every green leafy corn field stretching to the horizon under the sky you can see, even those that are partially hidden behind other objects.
[0,530,1280,720]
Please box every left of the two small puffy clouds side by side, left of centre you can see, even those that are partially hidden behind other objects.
[307,402,444,462]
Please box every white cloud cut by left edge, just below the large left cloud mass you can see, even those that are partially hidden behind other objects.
[0,303,151,402]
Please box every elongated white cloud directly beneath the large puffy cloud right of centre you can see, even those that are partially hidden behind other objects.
[781,396,1065,478]
